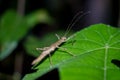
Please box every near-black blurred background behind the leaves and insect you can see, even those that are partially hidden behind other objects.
[0,0,120,80]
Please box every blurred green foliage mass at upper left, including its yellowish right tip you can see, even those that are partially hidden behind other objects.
[0,9,54,60]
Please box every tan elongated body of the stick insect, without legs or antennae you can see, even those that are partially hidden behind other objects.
[32,37,66,65]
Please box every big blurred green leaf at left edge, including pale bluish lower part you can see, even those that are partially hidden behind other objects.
[0,10,29,60]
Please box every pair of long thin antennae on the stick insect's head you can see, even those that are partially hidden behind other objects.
[64,11,90,36]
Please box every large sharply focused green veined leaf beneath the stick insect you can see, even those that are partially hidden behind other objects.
[23,24,120,80]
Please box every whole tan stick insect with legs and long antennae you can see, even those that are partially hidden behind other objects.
[31,12,88,65]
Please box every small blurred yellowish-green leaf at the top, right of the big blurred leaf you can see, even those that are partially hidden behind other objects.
[26,9,54,26]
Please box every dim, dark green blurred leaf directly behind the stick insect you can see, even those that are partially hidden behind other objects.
[24,30,73,57]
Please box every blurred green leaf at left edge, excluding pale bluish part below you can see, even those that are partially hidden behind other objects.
[0,10,29,42]
